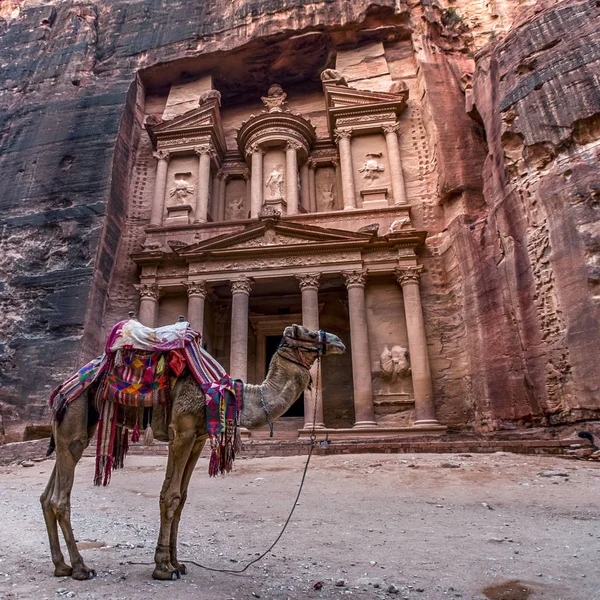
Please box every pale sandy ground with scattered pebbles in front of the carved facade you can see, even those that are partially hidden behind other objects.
[0,453,600,600]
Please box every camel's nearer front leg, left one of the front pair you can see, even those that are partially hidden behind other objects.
[152,425,196,580]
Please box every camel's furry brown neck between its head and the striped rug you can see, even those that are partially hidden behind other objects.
[240,348,316,429]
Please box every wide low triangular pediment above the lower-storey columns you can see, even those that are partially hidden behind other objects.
[176,220,371,256]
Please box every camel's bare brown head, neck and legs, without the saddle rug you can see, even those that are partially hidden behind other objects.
[40,325,345,580]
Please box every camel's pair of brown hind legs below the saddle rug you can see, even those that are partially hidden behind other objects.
[41,393,96,579]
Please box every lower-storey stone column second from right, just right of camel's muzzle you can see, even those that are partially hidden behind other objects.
[342,271,377,429]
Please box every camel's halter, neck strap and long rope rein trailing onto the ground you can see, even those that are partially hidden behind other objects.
[127,330,328,573]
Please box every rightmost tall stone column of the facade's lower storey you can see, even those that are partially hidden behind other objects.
[396,265,439,427]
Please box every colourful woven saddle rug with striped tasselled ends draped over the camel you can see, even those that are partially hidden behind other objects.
[50,319,244,485]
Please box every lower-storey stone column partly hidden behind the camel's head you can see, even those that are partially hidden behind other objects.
[296,273,325,429]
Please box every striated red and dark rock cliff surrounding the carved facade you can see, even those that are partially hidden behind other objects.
[0,0,600,437]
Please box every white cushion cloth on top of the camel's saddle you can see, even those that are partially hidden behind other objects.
[108,319,190,352]
